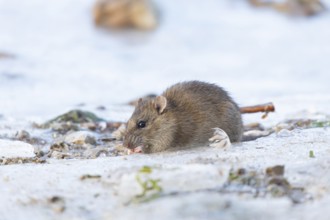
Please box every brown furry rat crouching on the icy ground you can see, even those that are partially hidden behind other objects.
[124,81,243,153]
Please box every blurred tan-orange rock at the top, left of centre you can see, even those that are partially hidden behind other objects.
[93,0,157,30]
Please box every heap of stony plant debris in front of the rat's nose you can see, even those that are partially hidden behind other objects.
[22,110,125,162]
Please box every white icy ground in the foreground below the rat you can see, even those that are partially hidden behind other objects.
[0,128,330,220]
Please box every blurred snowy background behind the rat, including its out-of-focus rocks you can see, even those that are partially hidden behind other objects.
[0,0,330,123]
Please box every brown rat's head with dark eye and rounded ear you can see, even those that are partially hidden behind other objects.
[124,96,173,153]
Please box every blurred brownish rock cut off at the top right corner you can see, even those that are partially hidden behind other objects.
[249,0,326,16]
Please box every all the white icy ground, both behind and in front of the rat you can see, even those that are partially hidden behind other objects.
[0,0,330,220]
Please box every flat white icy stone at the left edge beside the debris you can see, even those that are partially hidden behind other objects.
[0,139,35,158]
